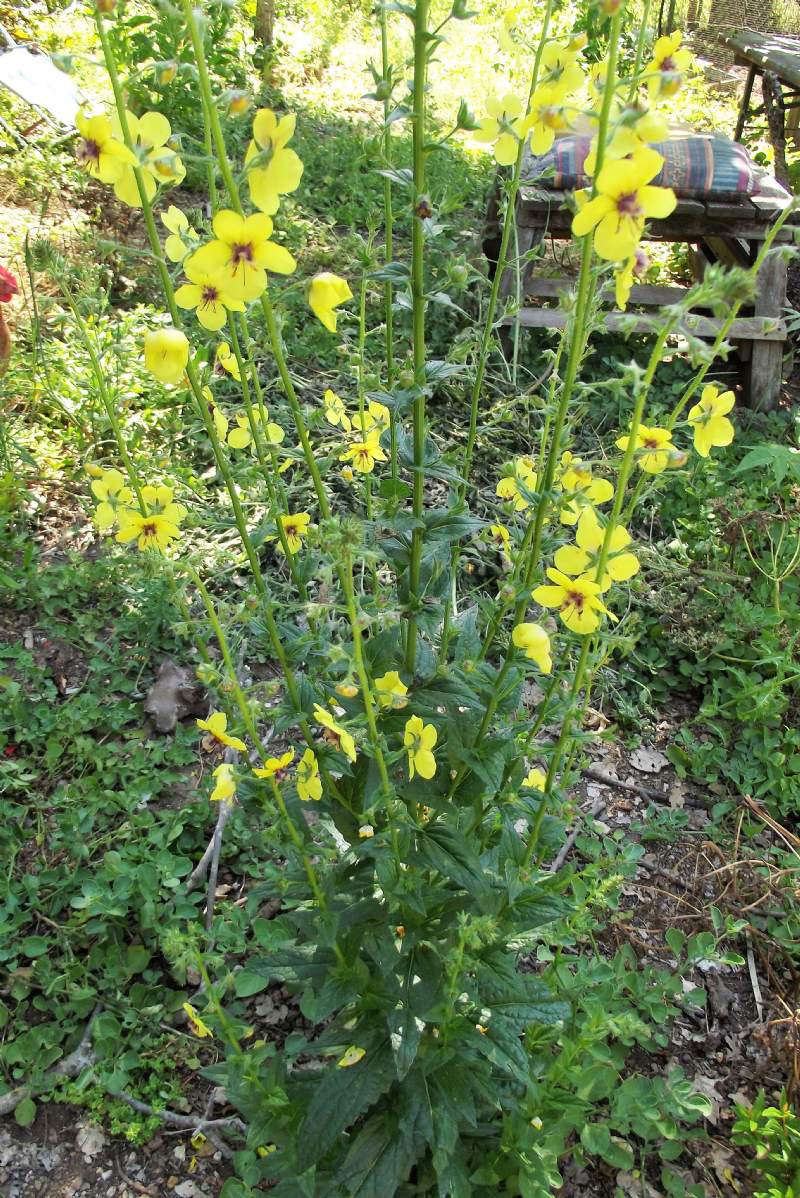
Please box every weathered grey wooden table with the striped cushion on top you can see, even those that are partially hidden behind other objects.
[510,161,794,409]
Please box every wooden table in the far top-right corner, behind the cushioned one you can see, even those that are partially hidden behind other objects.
[720,30,800,180]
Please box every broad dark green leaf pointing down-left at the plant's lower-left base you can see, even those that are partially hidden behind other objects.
[299,1042,395,1164]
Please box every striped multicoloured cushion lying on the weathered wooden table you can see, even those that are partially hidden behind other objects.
[525,133,759,200]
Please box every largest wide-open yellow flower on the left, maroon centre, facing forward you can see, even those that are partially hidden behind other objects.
[187,208,297,303]
